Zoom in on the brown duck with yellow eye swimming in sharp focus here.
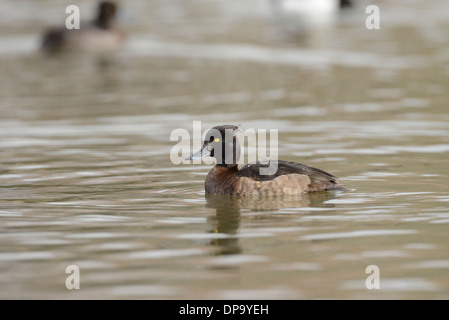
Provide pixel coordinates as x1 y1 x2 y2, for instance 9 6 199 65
186 125 349 197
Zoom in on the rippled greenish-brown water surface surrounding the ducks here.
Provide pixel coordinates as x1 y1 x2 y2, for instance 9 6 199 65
0 0 449 299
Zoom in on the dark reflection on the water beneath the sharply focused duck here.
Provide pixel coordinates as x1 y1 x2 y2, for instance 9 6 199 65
206 192 335 255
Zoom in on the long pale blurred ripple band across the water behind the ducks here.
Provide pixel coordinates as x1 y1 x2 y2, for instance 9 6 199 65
129 38 427 69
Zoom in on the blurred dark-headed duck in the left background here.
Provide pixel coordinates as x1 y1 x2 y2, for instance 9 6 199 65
41 1 126 53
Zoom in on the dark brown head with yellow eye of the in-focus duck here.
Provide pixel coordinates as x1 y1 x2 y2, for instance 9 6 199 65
186 125 241 167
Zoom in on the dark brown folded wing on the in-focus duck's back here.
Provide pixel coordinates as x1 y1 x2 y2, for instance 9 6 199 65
239 160 337 183
